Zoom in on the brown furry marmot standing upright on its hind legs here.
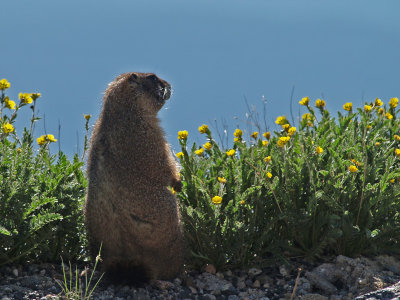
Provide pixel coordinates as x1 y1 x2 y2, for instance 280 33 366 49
84 73 185 281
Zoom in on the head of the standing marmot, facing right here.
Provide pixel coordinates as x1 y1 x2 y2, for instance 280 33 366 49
105 72 171 113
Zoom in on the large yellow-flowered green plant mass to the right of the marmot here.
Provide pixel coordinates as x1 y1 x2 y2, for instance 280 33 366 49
177 97 400 268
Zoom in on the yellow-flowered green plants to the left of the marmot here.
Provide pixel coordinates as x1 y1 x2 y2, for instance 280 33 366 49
0 79 86 265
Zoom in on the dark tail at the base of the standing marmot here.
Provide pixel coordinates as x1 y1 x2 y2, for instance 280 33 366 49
104 263 150 286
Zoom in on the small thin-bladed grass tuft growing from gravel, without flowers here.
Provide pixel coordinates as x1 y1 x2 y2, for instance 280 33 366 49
57 246 104 300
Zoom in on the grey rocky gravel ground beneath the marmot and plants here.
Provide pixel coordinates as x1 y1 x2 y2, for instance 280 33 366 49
0 256 400 300
